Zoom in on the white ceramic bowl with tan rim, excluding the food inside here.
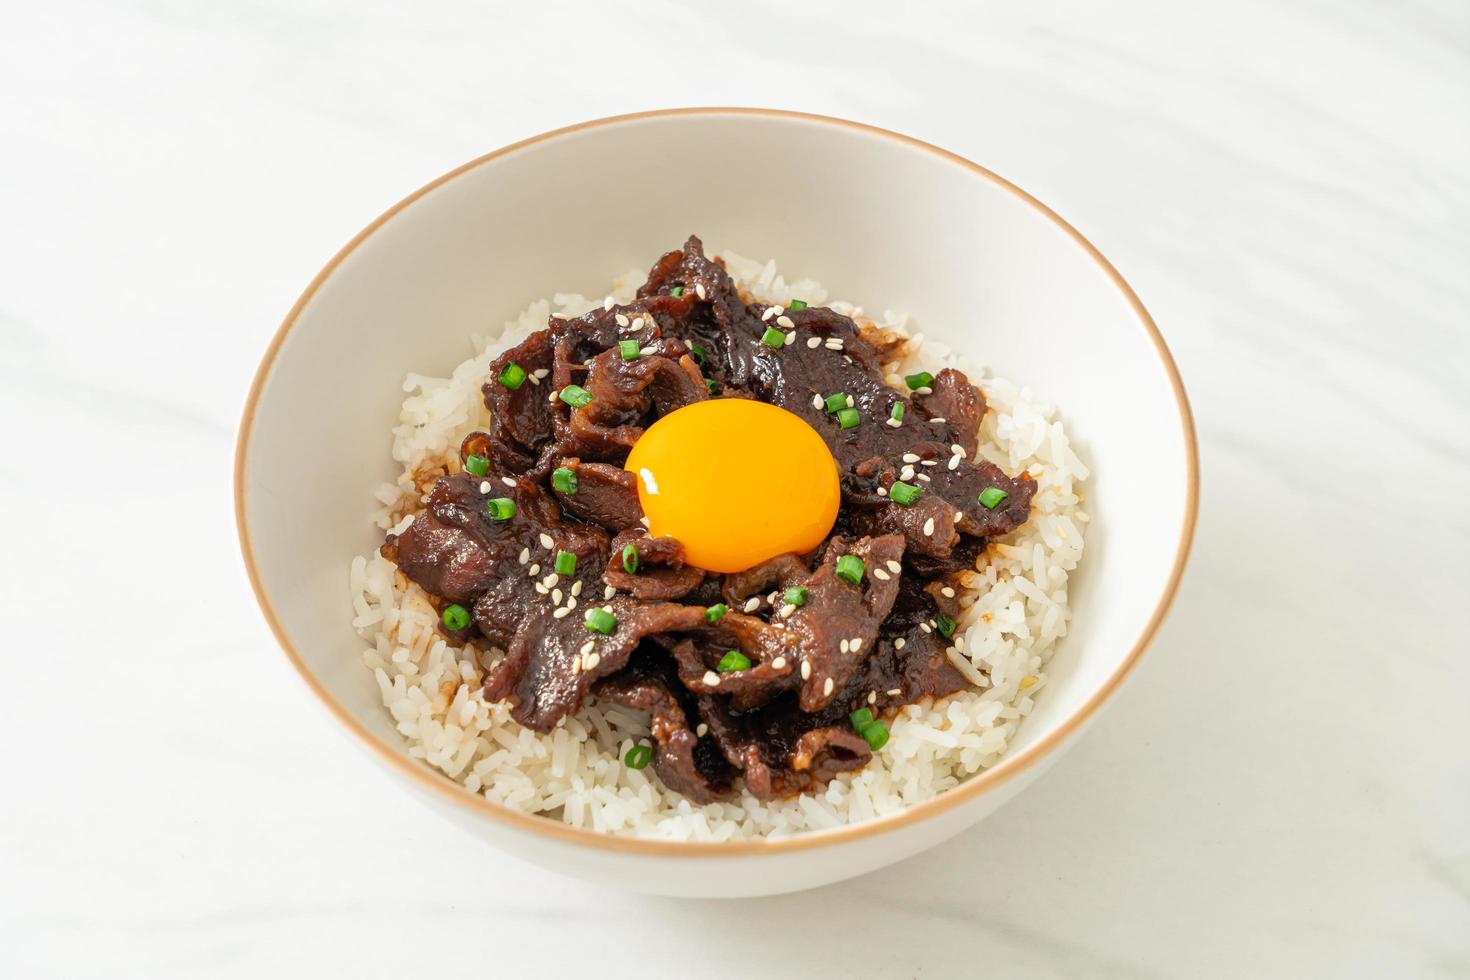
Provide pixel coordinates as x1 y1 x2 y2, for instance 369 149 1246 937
235 109 1198 896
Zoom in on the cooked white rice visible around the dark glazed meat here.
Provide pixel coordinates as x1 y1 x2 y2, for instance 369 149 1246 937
350 253 1088 840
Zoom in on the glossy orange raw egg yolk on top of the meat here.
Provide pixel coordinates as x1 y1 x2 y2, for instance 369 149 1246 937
623 398 839 572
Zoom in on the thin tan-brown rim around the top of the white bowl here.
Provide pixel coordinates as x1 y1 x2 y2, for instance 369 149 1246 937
234 106 1200 858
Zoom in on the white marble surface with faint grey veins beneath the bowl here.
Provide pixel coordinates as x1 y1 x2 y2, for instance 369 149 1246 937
0 0 1470 977
